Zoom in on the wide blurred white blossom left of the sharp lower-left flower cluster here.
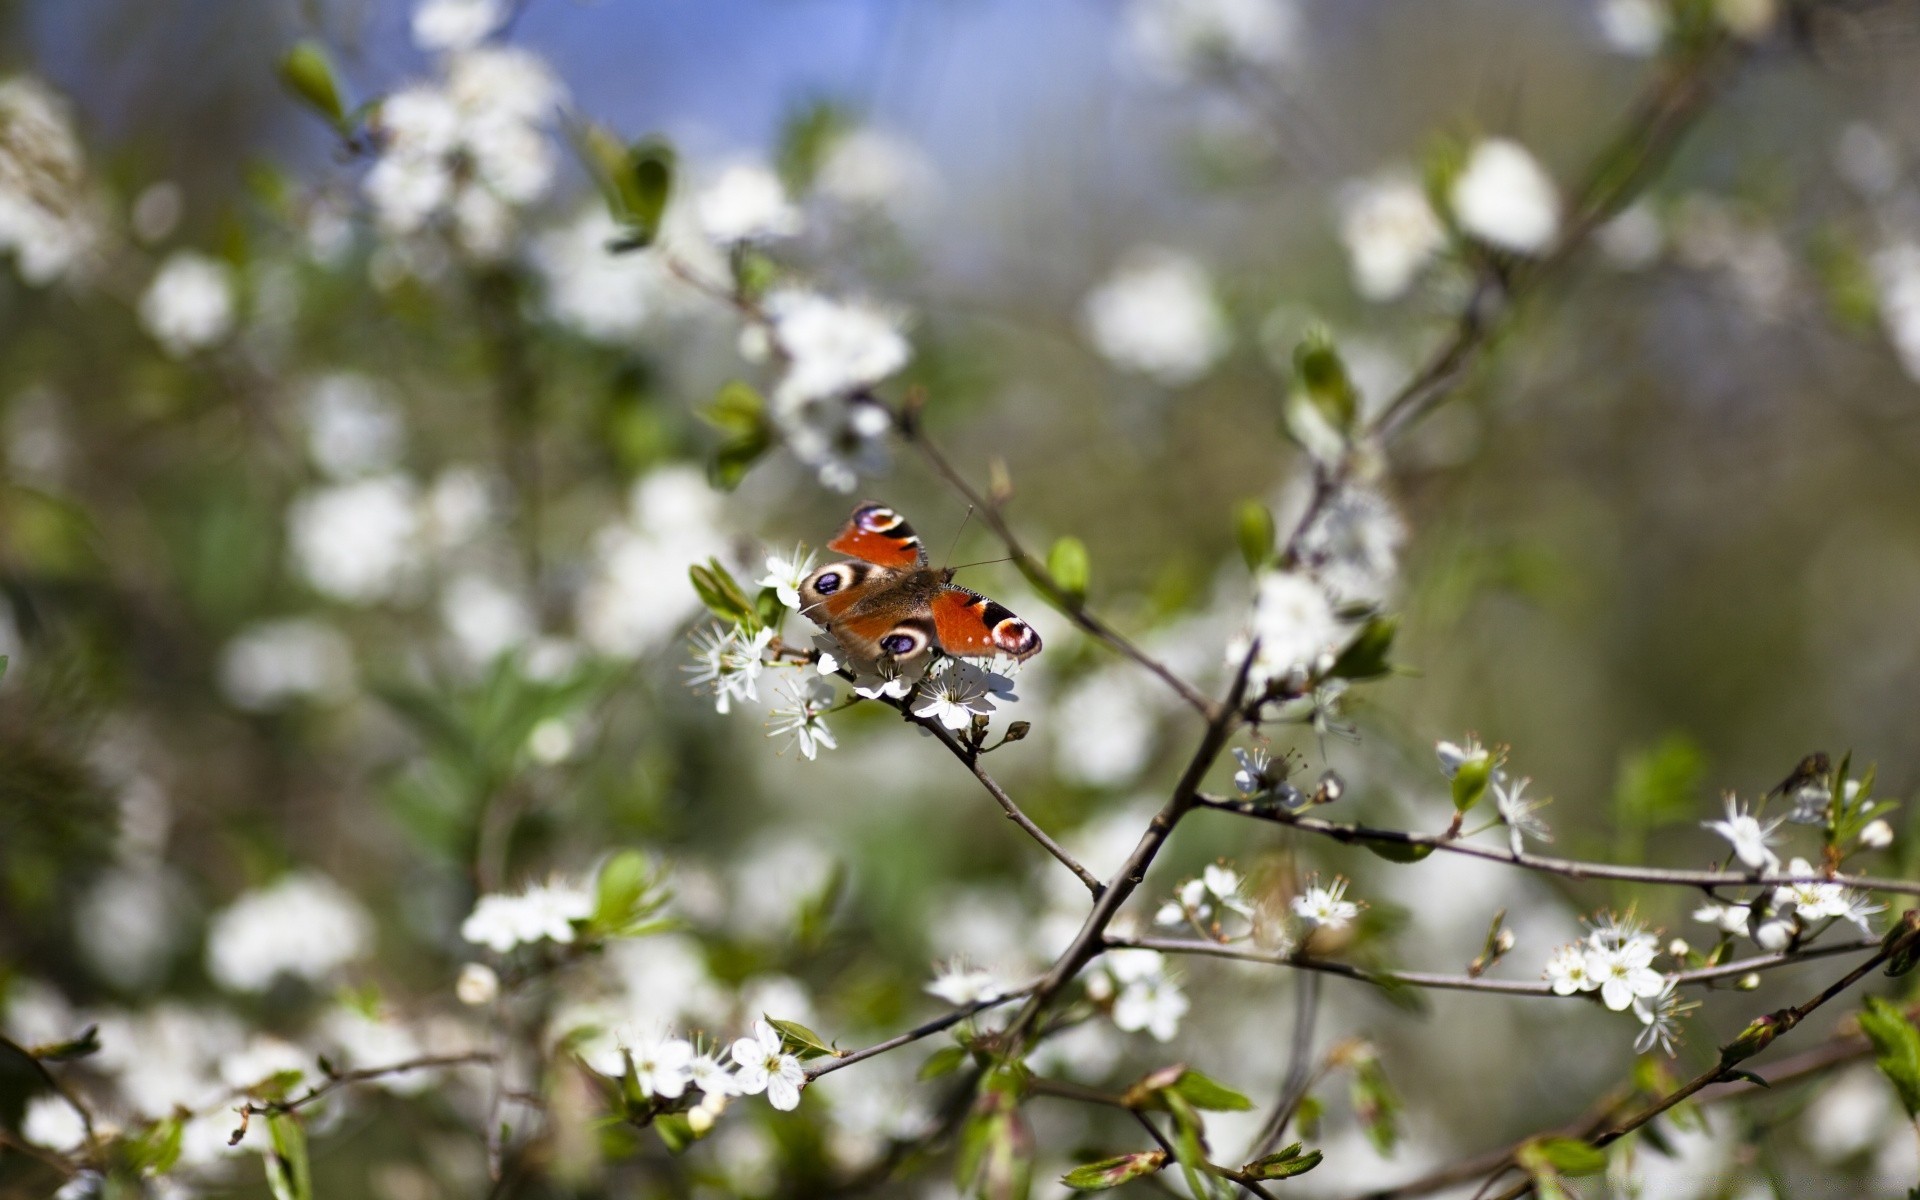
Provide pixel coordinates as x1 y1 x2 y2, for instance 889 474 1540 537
207 874 372 993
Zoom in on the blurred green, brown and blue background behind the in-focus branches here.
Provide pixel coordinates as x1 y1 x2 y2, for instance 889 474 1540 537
0 0 1920 1200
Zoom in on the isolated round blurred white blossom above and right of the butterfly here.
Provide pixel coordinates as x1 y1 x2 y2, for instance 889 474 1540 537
1081 248 1229 388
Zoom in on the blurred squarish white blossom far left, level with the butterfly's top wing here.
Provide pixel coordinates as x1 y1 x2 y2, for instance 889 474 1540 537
286 474 420 605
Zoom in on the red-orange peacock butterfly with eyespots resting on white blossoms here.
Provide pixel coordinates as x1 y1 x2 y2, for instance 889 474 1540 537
801 501 1041 676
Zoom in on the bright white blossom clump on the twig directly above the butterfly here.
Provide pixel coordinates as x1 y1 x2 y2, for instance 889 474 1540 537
762 288 912 415
